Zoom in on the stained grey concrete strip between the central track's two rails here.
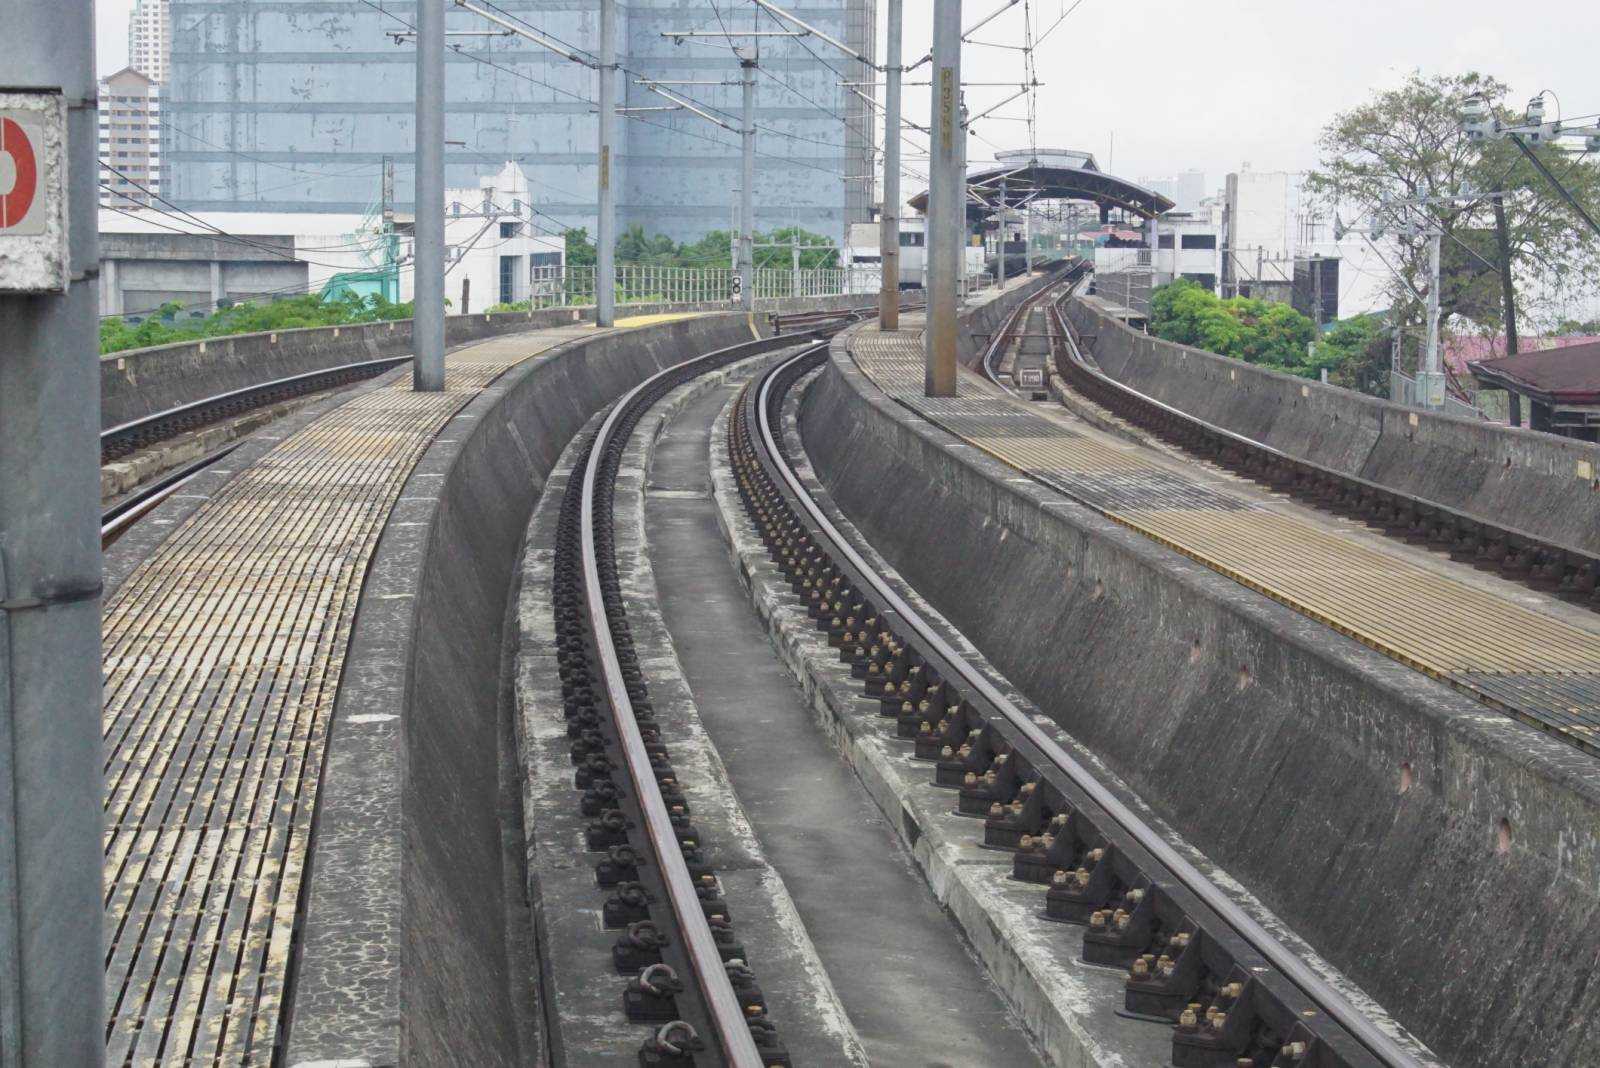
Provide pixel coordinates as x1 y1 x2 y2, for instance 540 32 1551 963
646 378 1038 1066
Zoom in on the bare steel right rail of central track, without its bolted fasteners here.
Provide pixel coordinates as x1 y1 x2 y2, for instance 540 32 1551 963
755 343 1421 1068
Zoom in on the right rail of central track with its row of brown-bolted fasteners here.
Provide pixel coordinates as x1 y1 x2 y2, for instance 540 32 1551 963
728 342 1418 1068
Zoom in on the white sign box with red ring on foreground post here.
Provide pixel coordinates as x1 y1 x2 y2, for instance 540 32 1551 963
0 91 69 293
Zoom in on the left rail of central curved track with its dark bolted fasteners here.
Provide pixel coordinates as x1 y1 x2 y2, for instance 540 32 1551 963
552 329 859 1068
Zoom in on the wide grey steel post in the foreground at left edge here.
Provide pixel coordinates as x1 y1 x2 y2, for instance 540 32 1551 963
0 0 106 1068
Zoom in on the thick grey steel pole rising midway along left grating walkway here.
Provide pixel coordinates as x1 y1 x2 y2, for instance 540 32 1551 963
411 0 445 392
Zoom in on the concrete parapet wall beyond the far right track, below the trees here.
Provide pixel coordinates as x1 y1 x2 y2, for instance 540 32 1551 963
1067 301 1600 553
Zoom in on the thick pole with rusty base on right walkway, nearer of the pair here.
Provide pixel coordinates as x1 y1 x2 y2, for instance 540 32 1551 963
923 0 966 397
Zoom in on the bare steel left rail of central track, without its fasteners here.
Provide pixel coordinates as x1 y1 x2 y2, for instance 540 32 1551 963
581 336 826 1068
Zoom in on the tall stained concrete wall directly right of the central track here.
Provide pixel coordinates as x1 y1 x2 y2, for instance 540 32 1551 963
800 319 1600 1068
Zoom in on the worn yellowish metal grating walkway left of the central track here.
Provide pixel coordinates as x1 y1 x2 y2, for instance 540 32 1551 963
95 323 604 1065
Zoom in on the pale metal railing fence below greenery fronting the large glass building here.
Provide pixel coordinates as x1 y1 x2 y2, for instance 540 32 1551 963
526 264 883 309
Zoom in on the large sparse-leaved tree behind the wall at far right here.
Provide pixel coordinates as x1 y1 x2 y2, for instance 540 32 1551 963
1306 72 1600 351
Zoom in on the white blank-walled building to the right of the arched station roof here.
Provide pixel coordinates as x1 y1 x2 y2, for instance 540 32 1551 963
1222 169 1294 301
